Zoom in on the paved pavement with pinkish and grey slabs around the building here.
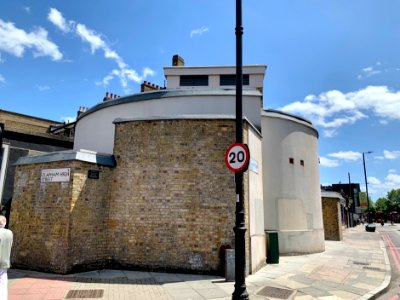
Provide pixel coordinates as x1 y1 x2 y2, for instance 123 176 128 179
8 225 391 300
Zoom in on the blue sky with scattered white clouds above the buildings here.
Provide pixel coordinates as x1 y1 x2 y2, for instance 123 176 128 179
0 0 400 200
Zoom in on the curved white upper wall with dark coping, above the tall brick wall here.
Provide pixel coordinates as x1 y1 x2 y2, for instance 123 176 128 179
74 90 261 154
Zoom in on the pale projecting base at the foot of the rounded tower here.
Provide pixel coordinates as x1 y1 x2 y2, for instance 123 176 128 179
278 228 325 255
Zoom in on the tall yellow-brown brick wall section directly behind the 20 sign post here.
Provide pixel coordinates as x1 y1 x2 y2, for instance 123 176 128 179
108 120 248 271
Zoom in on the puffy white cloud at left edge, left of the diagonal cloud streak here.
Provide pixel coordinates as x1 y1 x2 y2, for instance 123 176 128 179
0 19 62 60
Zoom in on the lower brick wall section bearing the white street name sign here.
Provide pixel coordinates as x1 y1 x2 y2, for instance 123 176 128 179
10 161 111 273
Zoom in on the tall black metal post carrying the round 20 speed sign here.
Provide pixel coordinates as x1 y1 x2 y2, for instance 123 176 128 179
232 0 249 300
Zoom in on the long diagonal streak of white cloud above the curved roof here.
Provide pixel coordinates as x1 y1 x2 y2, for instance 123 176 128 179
48 8 155 91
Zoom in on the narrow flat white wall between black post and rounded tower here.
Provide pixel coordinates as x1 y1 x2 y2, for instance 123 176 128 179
247 127 266 274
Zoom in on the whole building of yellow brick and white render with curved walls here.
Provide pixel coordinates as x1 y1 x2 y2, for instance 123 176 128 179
11 55 324 273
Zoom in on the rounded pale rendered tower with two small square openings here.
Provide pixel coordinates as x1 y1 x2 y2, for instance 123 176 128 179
261 111 325 254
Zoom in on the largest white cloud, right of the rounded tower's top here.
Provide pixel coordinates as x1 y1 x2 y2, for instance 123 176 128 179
279 86 400 137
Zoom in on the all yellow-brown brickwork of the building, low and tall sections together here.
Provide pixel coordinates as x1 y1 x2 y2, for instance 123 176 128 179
11 119 250 273
